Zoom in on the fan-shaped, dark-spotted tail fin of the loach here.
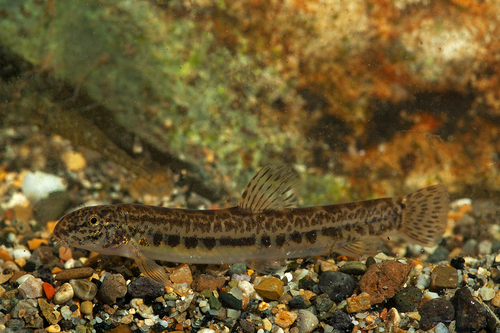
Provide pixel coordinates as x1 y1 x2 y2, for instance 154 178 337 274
399 185 449 246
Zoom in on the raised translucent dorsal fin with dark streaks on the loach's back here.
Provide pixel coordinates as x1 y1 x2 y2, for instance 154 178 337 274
238 164 298 212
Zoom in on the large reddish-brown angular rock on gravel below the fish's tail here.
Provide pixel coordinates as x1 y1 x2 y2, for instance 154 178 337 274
359 261 413 304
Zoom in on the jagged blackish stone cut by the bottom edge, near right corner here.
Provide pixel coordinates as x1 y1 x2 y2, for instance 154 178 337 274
452 287 487 332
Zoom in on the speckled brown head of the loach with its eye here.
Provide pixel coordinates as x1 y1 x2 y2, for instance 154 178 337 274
52 206 129 254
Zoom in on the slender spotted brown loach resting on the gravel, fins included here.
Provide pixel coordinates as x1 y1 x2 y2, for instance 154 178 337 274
53 165 449 286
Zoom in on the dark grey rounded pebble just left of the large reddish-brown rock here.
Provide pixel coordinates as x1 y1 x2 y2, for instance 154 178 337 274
318 271 356 302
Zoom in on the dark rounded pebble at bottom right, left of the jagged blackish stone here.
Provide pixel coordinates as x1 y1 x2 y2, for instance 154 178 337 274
418 298 455 331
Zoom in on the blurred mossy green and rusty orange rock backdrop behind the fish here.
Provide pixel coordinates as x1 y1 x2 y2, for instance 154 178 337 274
0 0 500 206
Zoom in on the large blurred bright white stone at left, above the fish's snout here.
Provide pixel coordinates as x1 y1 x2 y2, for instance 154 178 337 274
21 171 68 202
